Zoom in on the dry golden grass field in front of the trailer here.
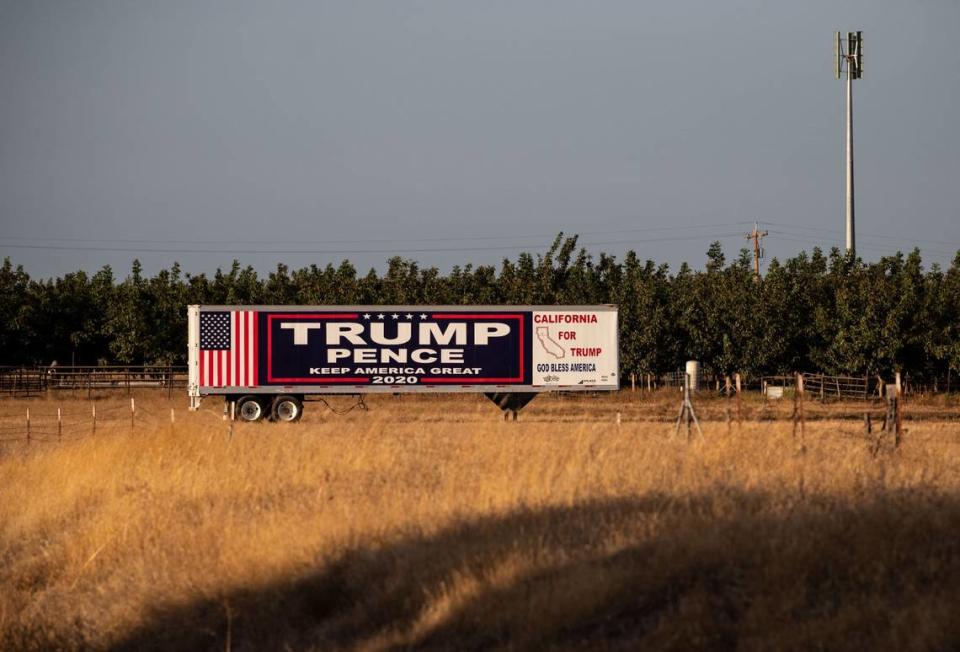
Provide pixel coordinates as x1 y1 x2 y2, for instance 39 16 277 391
0 392 960 650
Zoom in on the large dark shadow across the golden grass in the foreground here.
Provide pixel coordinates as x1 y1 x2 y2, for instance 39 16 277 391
116 491 960 650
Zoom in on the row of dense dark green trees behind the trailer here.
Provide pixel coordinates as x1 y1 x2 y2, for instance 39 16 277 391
0 233 960 380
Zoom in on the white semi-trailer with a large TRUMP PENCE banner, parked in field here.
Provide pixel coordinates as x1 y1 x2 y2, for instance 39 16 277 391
187 304 620 422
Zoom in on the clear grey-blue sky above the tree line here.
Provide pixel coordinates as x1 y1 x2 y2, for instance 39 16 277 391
0 0 960 277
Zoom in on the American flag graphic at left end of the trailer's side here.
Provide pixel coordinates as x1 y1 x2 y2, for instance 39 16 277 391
200 310 257 387
